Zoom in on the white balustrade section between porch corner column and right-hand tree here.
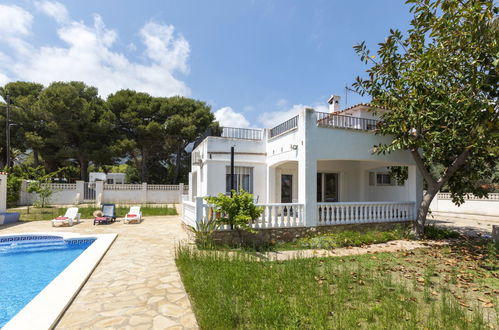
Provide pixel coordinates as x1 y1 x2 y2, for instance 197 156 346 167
317 202 415 226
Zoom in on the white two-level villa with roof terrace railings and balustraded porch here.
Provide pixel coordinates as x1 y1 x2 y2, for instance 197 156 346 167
183 96 423 228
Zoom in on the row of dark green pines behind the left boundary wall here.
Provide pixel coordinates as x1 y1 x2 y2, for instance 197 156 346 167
0 81 218 183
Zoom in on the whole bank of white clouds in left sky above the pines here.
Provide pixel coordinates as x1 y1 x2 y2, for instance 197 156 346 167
0 3 190 96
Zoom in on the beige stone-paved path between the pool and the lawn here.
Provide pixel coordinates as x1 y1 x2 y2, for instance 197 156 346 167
0 216 198 329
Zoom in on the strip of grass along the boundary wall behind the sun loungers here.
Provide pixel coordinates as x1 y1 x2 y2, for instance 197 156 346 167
9 204 177 221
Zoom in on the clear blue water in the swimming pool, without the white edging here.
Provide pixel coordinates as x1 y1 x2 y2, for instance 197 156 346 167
0 236 95 328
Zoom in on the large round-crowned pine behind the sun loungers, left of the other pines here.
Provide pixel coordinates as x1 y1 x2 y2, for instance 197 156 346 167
35 81 115 181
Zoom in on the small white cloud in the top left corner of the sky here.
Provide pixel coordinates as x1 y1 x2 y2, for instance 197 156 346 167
0 5 33 40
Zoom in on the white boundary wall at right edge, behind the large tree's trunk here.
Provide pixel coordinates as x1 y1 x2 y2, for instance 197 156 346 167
430 193 499 217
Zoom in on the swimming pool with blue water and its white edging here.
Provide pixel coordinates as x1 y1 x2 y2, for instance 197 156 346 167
0 233 116 329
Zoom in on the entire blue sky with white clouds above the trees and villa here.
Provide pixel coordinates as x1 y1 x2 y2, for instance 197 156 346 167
0 0 410 127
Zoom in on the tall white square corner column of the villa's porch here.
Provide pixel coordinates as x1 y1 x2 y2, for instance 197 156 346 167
298 109 317 227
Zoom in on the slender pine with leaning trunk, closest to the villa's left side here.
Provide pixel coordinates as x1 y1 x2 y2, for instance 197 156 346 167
164 96 218 183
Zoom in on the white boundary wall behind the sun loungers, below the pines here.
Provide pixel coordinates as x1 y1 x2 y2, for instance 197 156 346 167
18 181 189 205
